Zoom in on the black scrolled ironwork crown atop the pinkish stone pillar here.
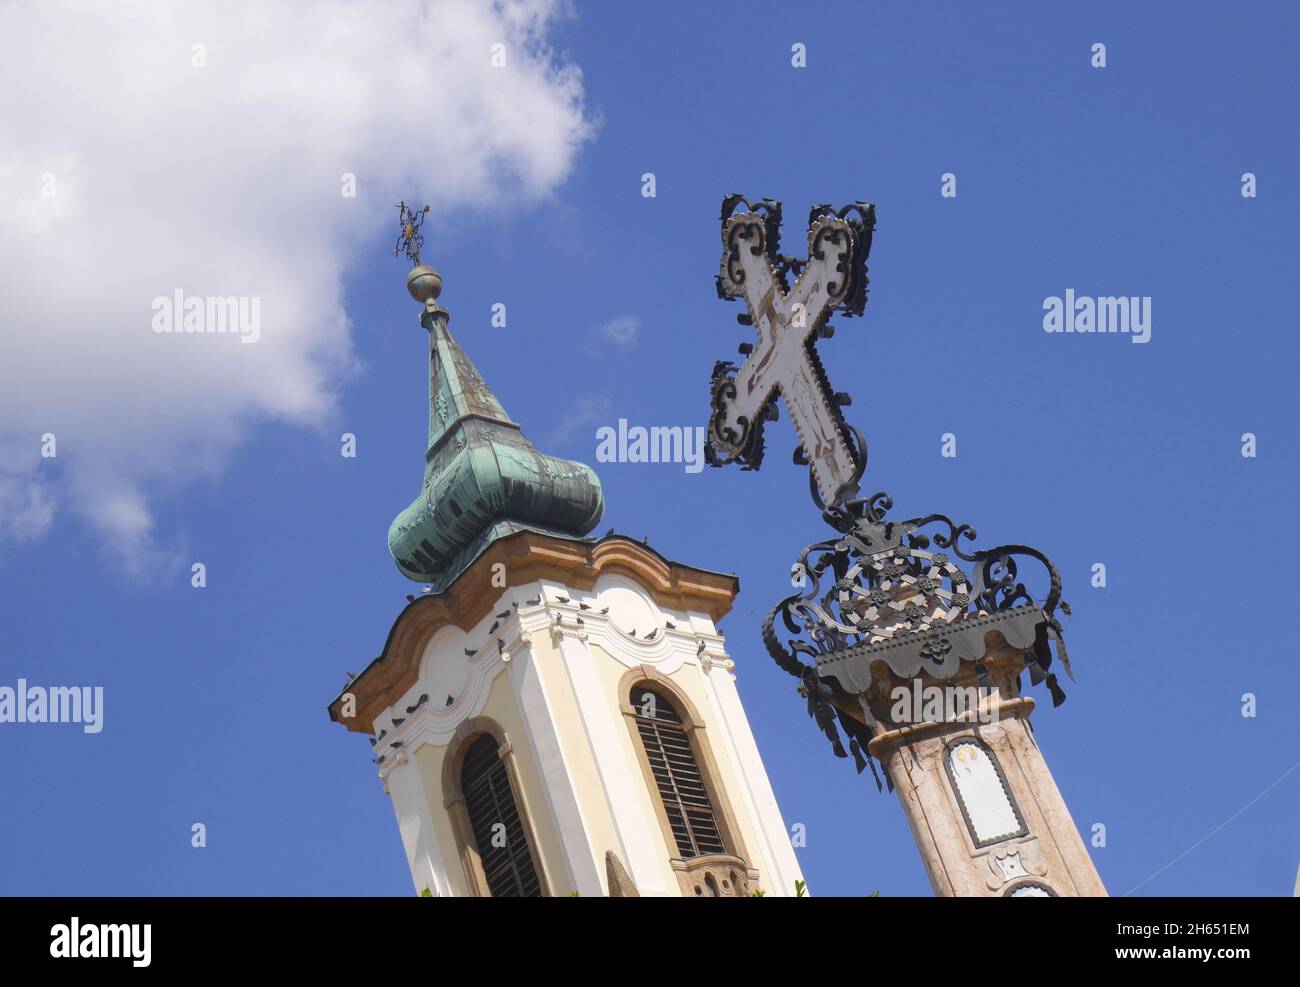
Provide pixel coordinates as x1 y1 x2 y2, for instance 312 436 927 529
763 493 1074 784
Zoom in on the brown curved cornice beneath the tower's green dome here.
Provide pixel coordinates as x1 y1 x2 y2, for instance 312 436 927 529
329 531 740 733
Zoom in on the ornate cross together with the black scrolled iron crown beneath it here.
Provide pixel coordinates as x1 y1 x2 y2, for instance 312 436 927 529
706 195 1074 785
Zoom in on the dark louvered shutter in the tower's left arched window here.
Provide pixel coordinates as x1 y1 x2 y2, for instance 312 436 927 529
460 733 542 897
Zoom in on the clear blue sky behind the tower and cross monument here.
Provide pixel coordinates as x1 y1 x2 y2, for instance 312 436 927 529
0 3 1300 896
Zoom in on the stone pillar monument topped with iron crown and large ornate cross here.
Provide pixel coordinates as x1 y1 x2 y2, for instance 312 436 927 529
706 195 1106 897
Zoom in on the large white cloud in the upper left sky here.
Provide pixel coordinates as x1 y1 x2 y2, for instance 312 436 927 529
0 0 592 568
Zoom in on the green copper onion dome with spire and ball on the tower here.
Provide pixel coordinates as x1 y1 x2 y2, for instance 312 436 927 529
389 264 605 593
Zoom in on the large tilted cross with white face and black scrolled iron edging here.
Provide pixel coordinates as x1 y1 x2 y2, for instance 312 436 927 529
707 195 875 506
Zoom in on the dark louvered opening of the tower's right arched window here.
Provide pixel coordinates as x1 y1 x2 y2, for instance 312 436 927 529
629 685 728 860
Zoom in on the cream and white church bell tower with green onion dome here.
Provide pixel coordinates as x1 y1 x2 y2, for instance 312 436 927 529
329 252 802 897
